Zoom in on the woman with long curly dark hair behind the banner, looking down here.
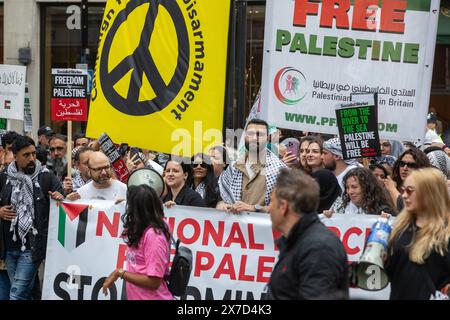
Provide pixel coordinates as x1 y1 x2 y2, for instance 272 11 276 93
324 168 396 217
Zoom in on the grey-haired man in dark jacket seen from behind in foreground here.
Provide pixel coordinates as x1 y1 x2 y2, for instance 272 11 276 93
268 169 349 300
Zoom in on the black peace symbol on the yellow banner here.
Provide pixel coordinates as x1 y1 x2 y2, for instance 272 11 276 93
100 0 189 116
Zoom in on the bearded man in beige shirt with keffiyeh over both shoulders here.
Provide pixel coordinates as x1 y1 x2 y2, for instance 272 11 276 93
219 119 286 213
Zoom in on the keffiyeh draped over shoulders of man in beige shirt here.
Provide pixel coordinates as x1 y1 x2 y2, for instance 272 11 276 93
219 150 287 205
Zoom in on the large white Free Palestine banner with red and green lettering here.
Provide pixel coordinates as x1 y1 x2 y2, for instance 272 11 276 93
261 0 439 141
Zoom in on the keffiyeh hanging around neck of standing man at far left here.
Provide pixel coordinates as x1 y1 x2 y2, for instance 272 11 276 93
7 160 48 251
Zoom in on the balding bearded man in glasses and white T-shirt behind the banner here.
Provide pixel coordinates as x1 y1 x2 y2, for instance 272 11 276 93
67 151 127 201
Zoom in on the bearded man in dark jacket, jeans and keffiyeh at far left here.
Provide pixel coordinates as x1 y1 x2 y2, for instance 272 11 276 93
0 135 63 300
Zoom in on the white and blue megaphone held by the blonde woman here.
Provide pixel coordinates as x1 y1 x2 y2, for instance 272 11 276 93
355 218 392 291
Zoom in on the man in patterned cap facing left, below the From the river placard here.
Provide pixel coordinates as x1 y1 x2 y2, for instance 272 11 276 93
322 138 358 190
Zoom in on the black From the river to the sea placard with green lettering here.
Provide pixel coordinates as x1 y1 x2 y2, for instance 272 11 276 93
336 94 380 160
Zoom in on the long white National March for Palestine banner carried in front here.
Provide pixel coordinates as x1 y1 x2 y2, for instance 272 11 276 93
43 200 389 300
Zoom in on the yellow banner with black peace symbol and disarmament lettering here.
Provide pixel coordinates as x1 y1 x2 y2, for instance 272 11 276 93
86 0 230 156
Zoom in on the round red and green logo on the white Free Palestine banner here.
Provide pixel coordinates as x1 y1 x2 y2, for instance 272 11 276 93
274 67 306 105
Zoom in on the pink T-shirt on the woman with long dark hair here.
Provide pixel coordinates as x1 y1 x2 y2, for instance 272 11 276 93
126 227 173 300
